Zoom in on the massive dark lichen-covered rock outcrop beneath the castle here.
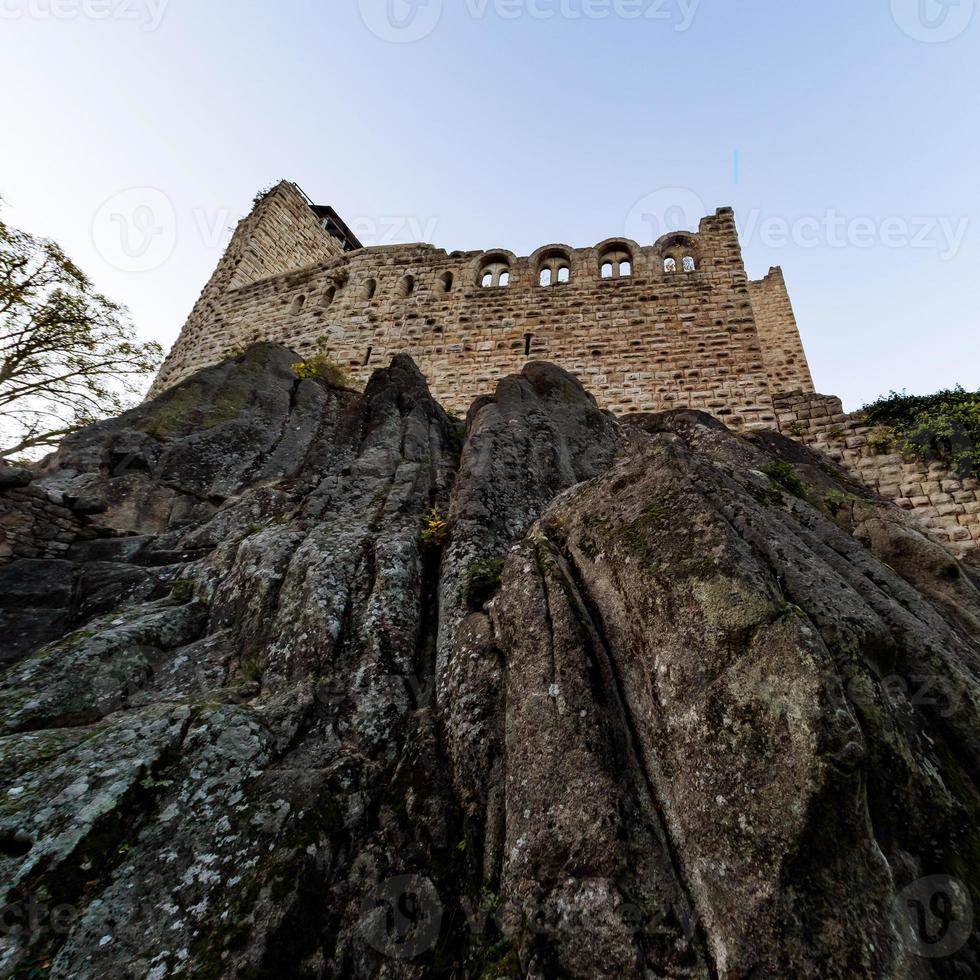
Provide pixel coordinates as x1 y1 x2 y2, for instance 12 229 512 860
0 345 980 978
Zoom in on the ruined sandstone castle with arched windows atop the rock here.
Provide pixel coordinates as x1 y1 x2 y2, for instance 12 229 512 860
152 182 813 427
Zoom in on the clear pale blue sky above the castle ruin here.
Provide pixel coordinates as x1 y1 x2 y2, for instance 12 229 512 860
0 0 980 408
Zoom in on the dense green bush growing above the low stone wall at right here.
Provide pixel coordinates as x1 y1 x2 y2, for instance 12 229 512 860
863 387 980 478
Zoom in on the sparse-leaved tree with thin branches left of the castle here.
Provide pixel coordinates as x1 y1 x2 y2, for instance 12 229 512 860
0 202 163 459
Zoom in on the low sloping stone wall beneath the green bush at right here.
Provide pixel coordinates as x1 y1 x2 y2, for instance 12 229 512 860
773 391 980 557
